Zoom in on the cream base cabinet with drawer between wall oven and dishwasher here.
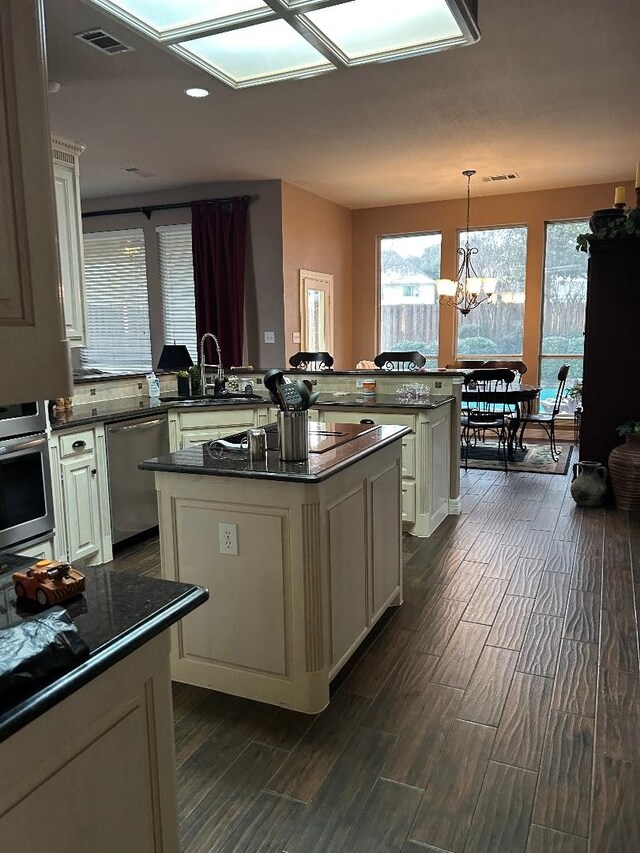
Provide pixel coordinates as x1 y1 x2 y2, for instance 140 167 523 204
49 424 112 565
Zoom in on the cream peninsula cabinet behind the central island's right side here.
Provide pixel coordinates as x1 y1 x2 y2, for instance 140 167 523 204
319 403 451 536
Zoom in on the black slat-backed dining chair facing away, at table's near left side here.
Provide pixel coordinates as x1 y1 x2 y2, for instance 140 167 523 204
460 368 515 471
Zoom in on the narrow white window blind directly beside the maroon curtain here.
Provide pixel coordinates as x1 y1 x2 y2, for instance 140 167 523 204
156 224 198 364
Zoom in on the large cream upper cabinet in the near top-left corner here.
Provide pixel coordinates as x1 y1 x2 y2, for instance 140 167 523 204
0 0 73 404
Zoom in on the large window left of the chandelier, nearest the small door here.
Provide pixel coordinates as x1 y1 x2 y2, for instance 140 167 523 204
380 234 442 367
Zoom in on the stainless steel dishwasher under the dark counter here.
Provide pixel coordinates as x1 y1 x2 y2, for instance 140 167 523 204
105 414 169 545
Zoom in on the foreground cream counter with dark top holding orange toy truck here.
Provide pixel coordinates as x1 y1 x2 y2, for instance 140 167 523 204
0 554 207 853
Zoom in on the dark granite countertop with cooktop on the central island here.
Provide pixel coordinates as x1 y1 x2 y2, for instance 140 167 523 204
138 421 411 483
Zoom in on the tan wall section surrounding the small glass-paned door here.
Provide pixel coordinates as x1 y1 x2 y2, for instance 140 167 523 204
282 181 353 370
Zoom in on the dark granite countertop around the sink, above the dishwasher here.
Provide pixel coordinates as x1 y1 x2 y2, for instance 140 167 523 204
50 397 267 430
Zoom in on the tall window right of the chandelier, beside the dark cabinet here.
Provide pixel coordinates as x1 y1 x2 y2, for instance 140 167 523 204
540 220 588 413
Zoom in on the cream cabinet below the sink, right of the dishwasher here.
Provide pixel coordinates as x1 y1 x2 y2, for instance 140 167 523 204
169 406 267 453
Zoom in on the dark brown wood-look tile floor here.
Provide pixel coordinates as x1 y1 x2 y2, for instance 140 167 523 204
107 456 640 853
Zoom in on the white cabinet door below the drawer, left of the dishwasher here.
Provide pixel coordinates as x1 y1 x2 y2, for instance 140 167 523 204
60 455 101 562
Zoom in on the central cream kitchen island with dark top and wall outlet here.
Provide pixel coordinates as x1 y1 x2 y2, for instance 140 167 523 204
141 419 409 713
